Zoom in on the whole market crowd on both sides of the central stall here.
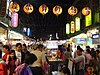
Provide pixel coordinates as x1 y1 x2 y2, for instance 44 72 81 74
0 43 100 75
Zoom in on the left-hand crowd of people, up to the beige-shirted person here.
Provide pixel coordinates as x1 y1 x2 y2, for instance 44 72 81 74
0 43 46 75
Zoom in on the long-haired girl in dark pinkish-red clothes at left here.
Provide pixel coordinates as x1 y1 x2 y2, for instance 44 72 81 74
6 50 20 75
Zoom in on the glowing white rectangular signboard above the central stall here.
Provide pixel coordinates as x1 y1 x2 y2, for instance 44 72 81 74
46 40 59 49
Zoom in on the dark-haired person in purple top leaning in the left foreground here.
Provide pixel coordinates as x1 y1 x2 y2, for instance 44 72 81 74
14 54 37 75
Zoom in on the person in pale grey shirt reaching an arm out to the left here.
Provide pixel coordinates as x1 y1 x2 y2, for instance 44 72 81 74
70 48 85 75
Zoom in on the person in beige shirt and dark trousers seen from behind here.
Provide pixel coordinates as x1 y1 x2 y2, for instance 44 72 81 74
30 44 46 75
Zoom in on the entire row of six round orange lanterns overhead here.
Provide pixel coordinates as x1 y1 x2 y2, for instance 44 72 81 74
9 2 91 16
